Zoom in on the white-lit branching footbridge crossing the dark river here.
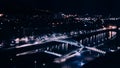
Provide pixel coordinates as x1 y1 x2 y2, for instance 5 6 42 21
16 36 106 63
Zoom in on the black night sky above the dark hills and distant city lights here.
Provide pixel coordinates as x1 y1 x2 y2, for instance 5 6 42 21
0 0 120 15
